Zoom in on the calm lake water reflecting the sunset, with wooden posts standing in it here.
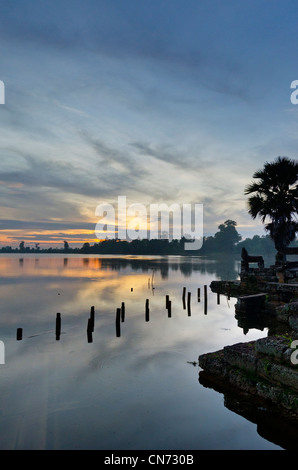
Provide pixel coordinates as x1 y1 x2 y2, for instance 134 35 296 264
0 254 294 450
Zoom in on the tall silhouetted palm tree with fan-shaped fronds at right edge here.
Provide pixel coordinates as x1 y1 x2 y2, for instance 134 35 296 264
245 157 298 253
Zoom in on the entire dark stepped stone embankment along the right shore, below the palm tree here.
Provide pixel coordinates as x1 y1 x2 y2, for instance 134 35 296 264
199 282 298 419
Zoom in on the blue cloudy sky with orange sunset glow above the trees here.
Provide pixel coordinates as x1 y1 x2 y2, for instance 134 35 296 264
0 0 298 247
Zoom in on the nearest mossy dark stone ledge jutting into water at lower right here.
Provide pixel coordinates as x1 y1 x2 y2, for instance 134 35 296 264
199 337 298 417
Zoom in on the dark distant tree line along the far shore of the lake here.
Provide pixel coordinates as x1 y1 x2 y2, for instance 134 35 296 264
0 219 298 255
